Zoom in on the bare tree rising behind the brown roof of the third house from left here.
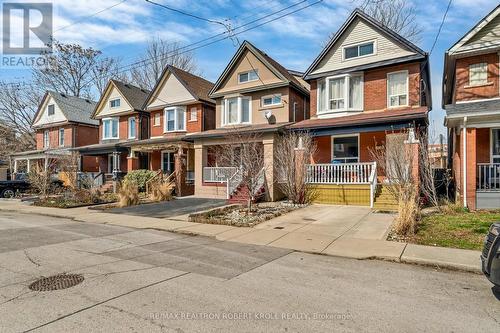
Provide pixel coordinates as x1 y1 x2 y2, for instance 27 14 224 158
130 38 197 90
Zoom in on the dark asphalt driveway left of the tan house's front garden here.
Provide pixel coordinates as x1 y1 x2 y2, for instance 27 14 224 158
106 197 226 220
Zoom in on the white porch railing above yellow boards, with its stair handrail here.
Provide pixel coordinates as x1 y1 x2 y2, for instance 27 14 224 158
306 162 377 207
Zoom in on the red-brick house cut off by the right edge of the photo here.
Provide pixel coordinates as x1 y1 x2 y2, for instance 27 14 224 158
442 6 500 209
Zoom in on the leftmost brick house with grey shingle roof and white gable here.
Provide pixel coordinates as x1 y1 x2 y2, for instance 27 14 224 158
12 91 99 174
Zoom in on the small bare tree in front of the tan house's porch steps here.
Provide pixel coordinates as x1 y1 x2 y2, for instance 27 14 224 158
216 129 267 213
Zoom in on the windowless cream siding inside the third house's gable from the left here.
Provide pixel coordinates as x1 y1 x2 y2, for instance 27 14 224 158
147 73 195 109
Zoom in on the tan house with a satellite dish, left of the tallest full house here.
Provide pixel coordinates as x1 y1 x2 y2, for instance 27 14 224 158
188 41 309 200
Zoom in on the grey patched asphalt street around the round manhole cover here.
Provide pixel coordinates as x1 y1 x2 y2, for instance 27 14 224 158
0 212 500 332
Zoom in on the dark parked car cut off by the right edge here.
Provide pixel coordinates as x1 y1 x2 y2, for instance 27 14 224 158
481 223 500 288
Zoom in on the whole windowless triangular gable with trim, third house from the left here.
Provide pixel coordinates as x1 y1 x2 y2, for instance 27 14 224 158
144 66 198 110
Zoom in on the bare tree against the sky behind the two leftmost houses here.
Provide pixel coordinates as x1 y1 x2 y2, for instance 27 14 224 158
32 40 122 98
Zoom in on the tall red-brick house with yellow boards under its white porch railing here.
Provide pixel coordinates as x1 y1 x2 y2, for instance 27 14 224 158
291 9 431 208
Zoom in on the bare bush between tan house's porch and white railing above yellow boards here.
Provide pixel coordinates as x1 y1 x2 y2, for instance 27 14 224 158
274 132 316 204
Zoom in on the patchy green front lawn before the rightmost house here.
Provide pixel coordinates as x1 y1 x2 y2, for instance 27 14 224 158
408 211 500 250
